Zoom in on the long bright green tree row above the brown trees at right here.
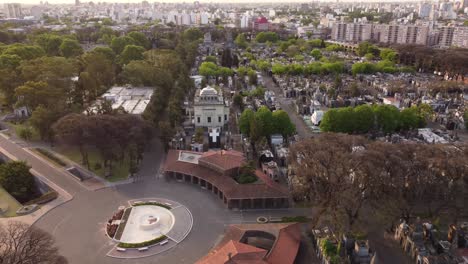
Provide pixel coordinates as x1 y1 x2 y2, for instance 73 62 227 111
320 104 432 134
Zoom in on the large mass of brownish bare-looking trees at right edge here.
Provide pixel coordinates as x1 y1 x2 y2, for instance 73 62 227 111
290 133 468 235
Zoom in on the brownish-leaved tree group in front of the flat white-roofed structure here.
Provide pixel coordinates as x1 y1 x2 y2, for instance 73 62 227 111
53 113 151 173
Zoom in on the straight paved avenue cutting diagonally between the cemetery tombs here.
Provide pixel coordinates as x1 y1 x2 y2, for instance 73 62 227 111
262 75 314 138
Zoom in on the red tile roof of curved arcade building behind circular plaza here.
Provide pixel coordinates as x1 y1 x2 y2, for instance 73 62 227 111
163 150 289 199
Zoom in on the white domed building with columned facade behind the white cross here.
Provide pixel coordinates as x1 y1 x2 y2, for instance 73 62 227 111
193 86 229 128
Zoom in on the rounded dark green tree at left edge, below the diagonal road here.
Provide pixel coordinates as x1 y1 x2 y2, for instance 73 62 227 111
0 161 38 203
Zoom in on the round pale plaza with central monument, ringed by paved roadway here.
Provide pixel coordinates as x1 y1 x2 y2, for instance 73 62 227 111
106 198 193 258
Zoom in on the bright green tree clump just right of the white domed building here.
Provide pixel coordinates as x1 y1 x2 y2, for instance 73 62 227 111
239 106 296 149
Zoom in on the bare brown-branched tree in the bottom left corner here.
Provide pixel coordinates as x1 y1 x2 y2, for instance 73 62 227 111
0 221 68 264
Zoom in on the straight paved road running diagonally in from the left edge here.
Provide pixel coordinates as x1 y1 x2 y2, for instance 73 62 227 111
0 134 86 196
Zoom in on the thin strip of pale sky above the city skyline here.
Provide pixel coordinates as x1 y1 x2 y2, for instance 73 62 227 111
0 0 422 7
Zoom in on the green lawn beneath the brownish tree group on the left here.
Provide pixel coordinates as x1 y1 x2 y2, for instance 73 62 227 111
54 146 130 182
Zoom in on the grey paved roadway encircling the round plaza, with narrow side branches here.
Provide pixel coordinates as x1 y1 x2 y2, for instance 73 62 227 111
31 138 308 264
